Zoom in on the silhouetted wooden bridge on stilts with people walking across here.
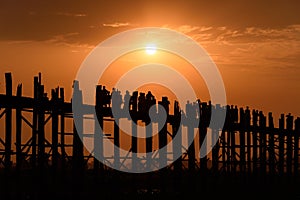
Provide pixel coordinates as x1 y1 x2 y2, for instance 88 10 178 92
0 73 300 199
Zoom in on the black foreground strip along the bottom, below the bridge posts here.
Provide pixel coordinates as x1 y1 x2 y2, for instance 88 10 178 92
0 170 300 200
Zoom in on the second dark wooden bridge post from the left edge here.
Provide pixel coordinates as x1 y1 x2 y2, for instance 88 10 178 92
16 84 22 171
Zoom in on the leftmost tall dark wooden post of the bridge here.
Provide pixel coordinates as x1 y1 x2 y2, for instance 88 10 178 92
4 73 12 169
